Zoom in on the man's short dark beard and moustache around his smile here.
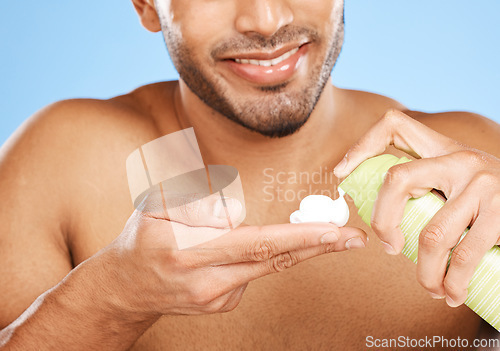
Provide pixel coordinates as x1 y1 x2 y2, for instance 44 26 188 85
162 18 344 138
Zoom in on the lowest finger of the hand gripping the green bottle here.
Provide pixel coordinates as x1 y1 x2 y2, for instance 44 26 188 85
444 214 500 307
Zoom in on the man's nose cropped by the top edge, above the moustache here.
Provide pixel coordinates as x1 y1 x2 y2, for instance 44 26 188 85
235 0 293 37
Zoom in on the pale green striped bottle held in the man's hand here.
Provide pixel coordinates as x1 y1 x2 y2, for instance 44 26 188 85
339 154 500 331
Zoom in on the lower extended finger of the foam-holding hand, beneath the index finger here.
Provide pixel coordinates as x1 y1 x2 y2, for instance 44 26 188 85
211 227 368 293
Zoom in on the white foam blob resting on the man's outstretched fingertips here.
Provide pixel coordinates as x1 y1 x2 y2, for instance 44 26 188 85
290 189 349 227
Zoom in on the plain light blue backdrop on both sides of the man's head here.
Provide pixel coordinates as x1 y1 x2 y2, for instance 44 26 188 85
0 0 500 145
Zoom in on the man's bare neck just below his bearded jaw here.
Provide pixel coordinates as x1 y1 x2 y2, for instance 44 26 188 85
174 80 340 173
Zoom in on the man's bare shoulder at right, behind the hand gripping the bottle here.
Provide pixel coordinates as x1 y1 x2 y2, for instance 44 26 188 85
403 110 500 157
